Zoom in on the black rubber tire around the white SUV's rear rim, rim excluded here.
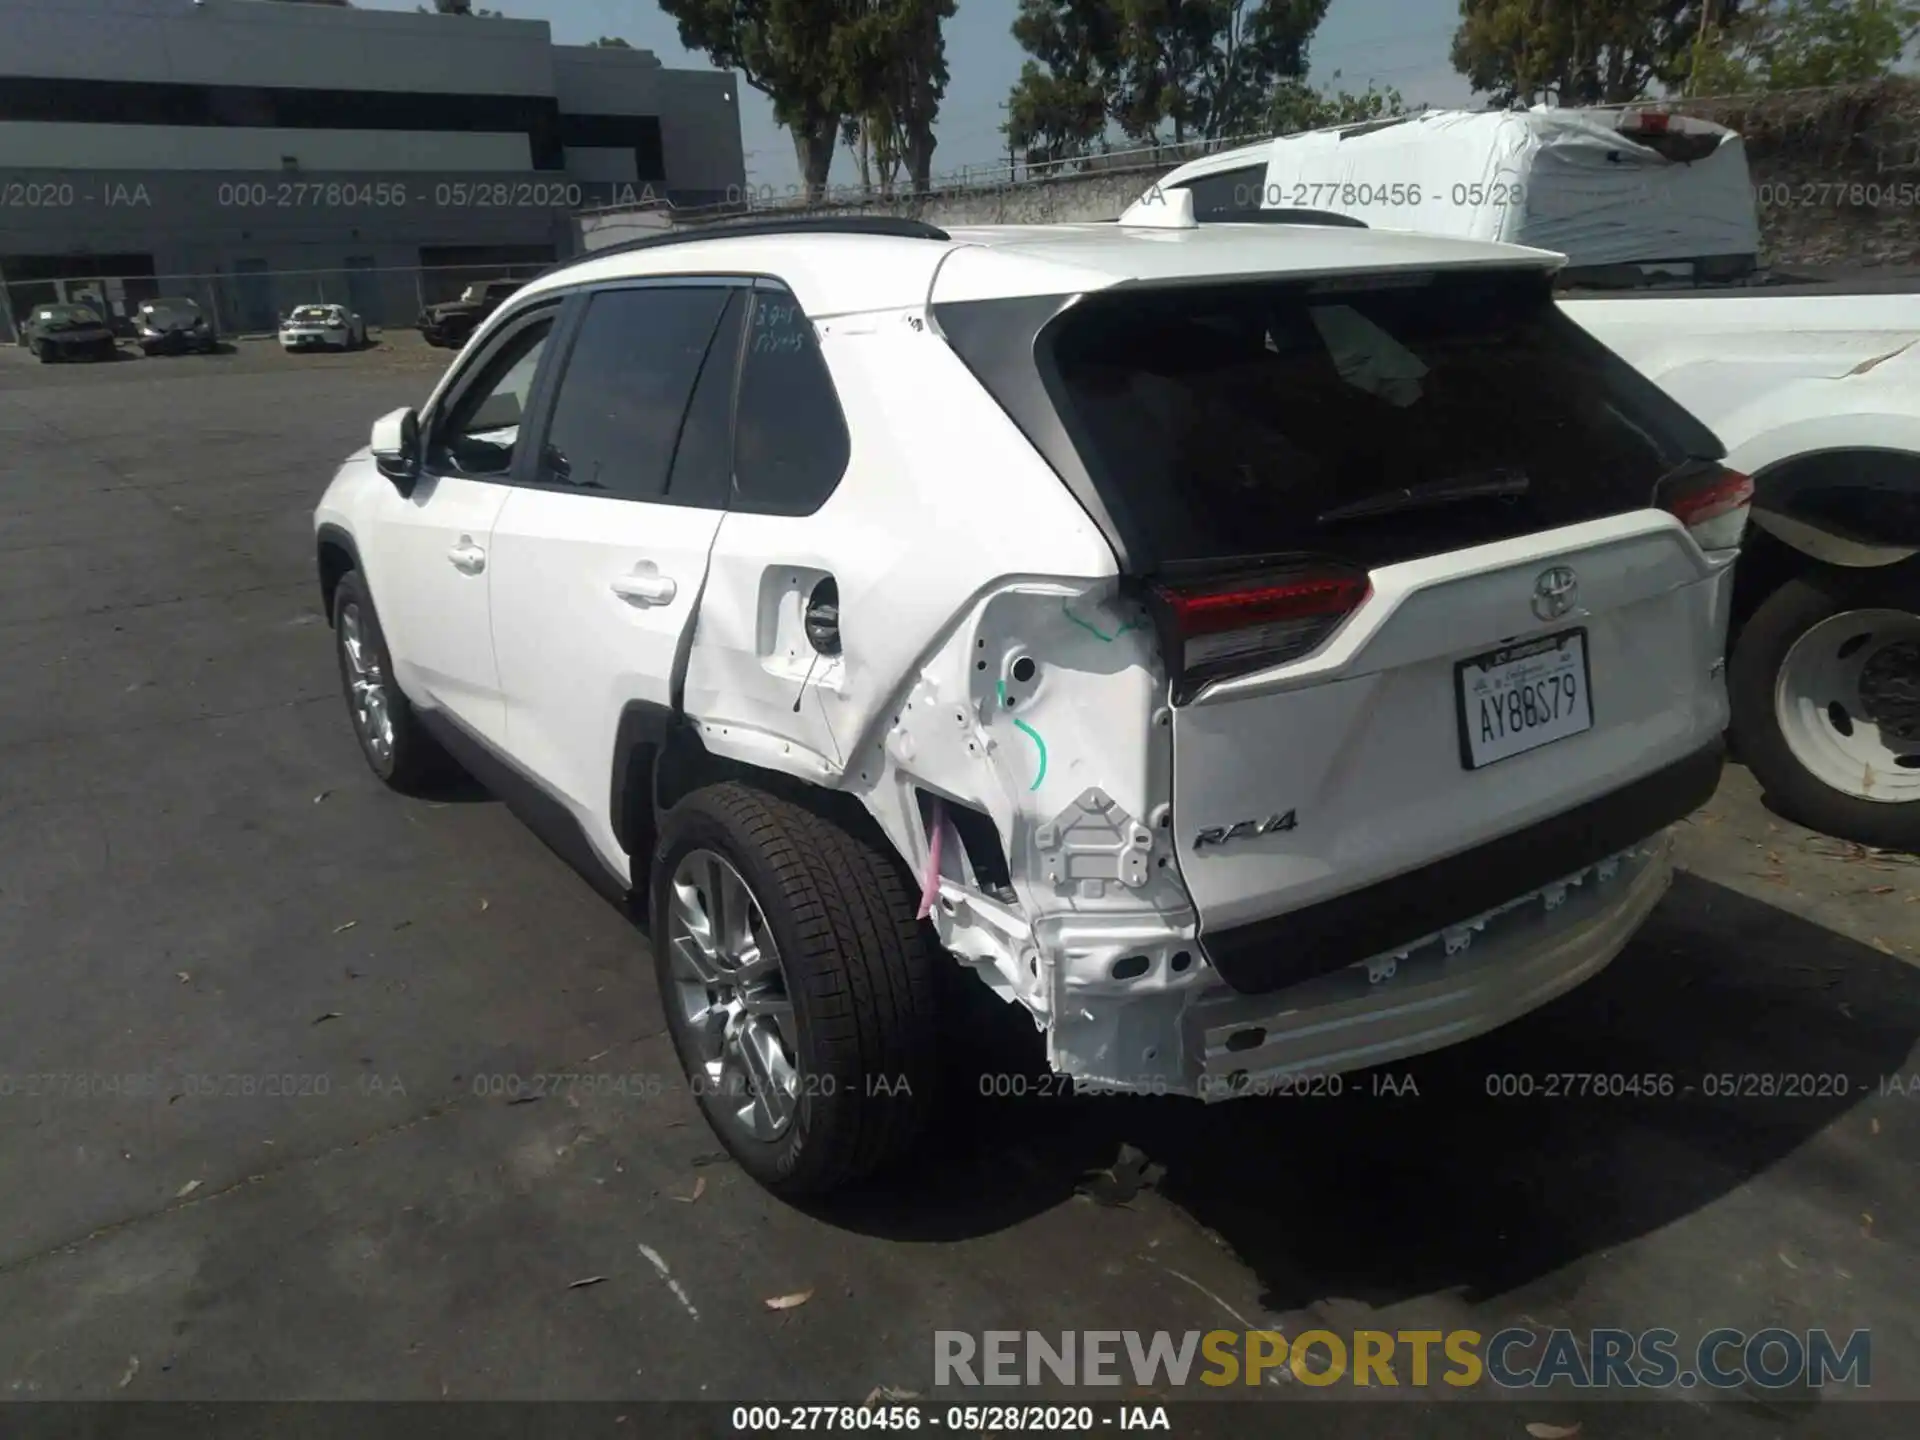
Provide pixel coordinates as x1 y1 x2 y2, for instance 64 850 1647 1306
649 781 939 1198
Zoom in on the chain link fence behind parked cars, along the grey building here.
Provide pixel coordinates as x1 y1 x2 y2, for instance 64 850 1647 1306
0 261 551 344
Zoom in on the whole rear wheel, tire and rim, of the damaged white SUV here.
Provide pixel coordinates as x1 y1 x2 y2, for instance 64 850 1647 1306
651 781 937 1196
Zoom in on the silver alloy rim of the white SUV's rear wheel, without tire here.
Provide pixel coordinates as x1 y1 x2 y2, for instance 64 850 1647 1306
666 851 801 1142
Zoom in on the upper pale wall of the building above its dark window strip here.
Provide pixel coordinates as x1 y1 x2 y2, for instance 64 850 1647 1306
0 0 553 96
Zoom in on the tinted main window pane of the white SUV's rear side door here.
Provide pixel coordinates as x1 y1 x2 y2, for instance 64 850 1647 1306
538 286 732 501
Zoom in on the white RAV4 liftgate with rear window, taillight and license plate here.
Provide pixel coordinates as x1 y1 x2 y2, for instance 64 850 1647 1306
1050 275 1730 989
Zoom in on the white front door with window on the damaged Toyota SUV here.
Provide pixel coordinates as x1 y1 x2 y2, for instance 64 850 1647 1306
367 309 555 745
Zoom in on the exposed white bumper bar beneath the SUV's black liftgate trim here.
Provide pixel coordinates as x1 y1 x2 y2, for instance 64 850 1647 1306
1183 831 1672 1100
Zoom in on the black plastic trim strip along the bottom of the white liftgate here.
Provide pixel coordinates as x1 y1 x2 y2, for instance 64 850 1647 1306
1200 739 1726 995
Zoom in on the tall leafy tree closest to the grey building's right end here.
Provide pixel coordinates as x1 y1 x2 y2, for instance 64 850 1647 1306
660 0 851 196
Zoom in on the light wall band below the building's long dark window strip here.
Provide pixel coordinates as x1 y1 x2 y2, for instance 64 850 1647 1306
0 121 529 179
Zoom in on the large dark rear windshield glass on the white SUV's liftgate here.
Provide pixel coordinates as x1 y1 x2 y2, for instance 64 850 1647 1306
1043 275 1720 568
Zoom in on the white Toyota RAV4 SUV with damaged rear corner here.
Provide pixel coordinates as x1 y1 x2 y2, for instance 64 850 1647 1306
315 204 1747 1192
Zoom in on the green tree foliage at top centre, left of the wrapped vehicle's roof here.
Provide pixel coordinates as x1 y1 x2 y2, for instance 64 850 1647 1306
1006 0 1327 159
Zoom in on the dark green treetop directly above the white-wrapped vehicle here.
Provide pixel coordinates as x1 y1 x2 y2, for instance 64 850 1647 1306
1452 0 1743 106
